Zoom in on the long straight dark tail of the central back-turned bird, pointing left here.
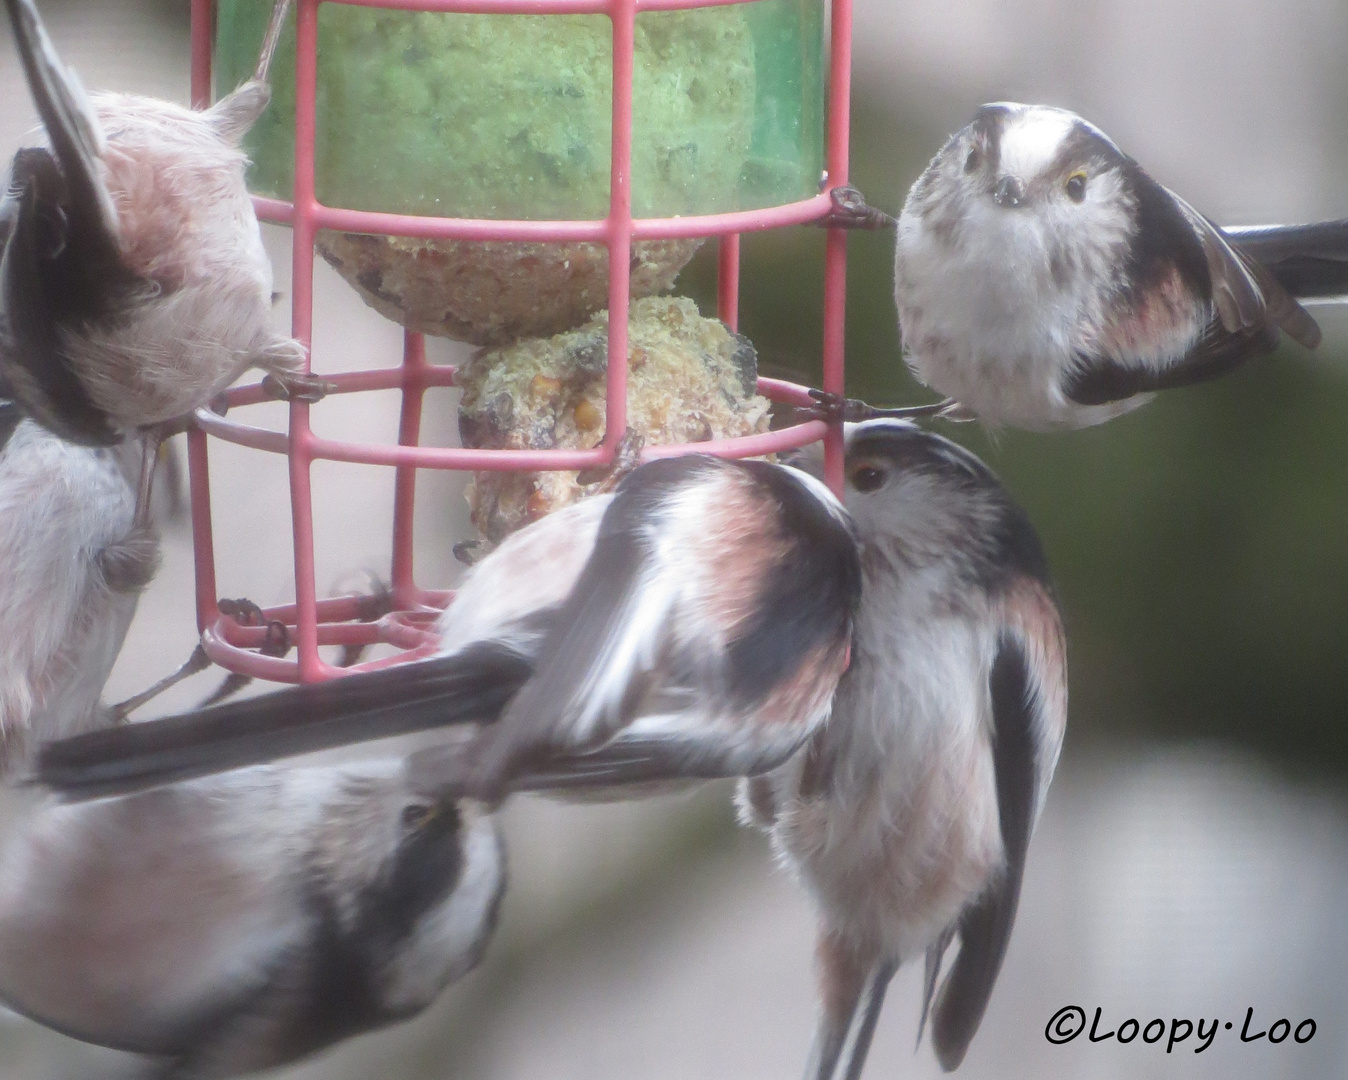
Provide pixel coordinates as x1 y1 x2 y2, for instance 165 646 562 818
32 642 532 801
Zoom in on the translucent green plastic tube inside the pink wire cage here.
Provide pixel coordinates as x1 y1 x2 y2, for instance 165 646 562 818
214 0 825 220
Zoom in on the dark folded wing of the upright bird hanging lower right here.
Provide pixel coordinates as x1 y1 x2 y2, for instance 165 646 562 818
931 634 1038 1072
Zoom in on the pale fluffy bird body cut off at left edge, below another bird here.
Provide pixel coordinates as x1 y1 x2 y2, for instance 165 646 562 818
0 402 159 773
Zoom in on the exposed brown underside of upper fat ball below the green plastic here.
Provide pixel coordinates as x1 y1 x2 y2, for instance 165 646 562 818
318 232 702 345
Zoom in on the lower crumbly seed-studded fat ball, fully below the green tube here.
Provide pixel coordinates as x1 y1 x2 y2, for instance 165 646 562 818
457 297 770 545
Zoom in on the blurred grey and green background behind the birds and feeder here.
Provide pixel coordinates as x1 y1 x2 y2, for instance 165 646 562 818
0 0 1348 1080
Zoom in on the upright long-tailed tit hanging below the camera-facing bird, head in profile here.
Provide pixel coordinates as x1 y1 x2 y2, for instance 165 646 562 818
740 421 1068 1080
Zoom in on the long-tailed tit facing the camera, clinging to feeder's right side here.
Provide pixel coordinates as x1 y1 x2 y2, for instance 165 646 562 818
822 102 1326 430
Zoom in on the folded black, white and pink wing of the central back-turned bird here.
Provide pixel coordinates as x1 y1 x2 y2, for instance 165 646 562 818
410 456 860 797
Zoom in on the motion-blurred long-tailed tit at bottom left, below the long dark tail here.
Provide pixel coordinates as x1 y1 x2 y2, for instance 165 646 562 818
0 759 506 1080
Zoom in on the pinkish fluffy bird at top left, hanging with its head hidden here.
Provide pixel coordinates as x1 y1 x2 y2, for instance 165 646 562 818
0 0 322 525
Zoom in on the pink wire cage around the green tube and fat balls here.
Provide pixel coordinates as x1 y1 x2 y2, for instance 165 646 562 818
187 0 852 682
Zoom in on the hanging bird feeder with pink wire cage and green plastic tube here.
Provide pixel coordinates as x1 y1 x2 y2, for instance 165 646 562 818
189 0 851 682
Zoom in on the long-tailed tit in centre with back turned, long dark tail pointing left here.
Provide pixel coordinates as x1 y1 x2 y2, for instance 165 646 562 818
36 456 860 798
